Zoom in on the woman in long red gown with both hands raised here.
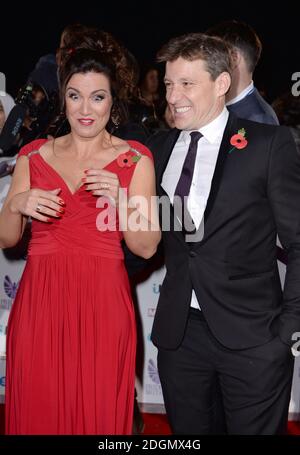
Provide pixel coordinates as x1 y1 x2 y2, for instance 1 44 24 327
0 39 160 434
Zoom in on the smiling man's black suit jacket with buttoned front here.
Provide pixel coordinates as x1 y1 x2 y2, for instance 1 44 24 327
148 114 300 349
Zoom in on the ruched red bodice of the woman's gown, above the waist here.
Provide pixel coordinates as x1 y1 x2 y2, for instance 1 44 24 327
24 141 149 259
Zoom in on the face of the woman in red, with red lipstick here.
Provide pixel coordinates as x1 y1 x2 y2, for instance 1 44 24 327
65 72 113 138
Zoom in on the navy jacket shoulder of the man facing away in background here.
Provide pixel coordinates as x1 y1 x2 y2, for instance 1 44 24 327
227 88 279 125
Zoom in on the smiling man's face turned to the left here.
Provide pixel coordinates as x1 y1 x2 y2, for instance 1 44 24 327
165 57 227 131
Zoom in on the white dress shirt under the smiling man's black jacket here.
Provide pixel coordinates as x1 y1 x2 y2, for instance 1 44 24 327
161 107 229 309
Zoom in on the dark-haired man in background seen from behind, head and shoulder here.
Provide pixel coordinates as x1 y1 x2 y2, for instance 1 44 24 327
206 20 278 125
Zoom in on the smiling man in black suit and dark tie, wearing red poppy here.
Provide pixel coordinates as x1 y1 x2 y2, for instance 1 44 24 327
148 34 300 434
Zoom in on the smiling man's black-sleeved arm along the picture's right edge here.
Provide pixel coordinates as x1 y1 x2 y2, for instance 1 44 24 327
268 127 300 345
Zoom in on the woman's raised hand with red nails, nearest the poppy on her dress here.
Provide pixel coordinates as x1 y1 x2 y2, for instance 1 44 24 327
82 169 120 205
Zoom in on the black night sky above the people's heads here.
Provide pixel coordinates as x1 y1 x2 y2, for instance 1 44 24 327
0 0 300 101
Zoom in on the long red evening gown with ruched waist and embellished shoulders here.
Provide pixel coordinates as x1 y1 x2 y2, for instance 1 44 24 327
6 139 151 434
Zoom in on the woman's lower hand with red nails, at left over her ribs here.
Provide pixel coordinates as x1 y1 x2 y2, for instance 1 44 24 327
9 188 65 222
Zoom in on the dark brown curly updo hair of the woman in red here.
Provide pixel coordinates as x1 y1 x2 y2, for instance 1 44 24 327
59 26 137 124
